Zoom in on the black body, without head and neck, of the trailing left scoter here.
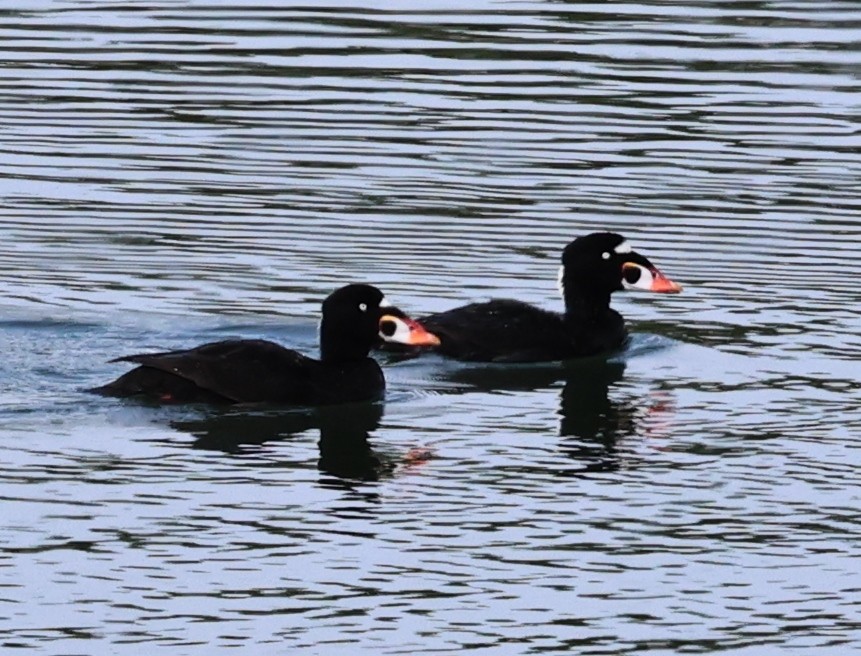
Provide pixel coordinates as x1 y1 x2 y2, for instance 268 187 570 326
93 339 386 405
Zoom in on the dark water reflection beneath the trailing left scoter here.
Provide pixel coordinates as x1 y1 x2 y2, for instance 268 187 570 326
171 403 397 481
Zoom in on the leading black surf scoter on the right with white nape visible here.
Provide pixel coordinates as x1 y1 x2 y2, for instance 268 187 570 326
394 232 682 362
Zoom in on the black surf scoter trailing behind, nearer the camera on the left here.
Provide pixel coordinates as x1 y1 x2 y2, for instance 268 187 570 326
91 284 439 405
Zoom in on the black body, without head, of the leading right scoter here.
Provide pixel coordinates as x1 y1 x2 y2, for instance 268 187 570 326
419 299 627 362
